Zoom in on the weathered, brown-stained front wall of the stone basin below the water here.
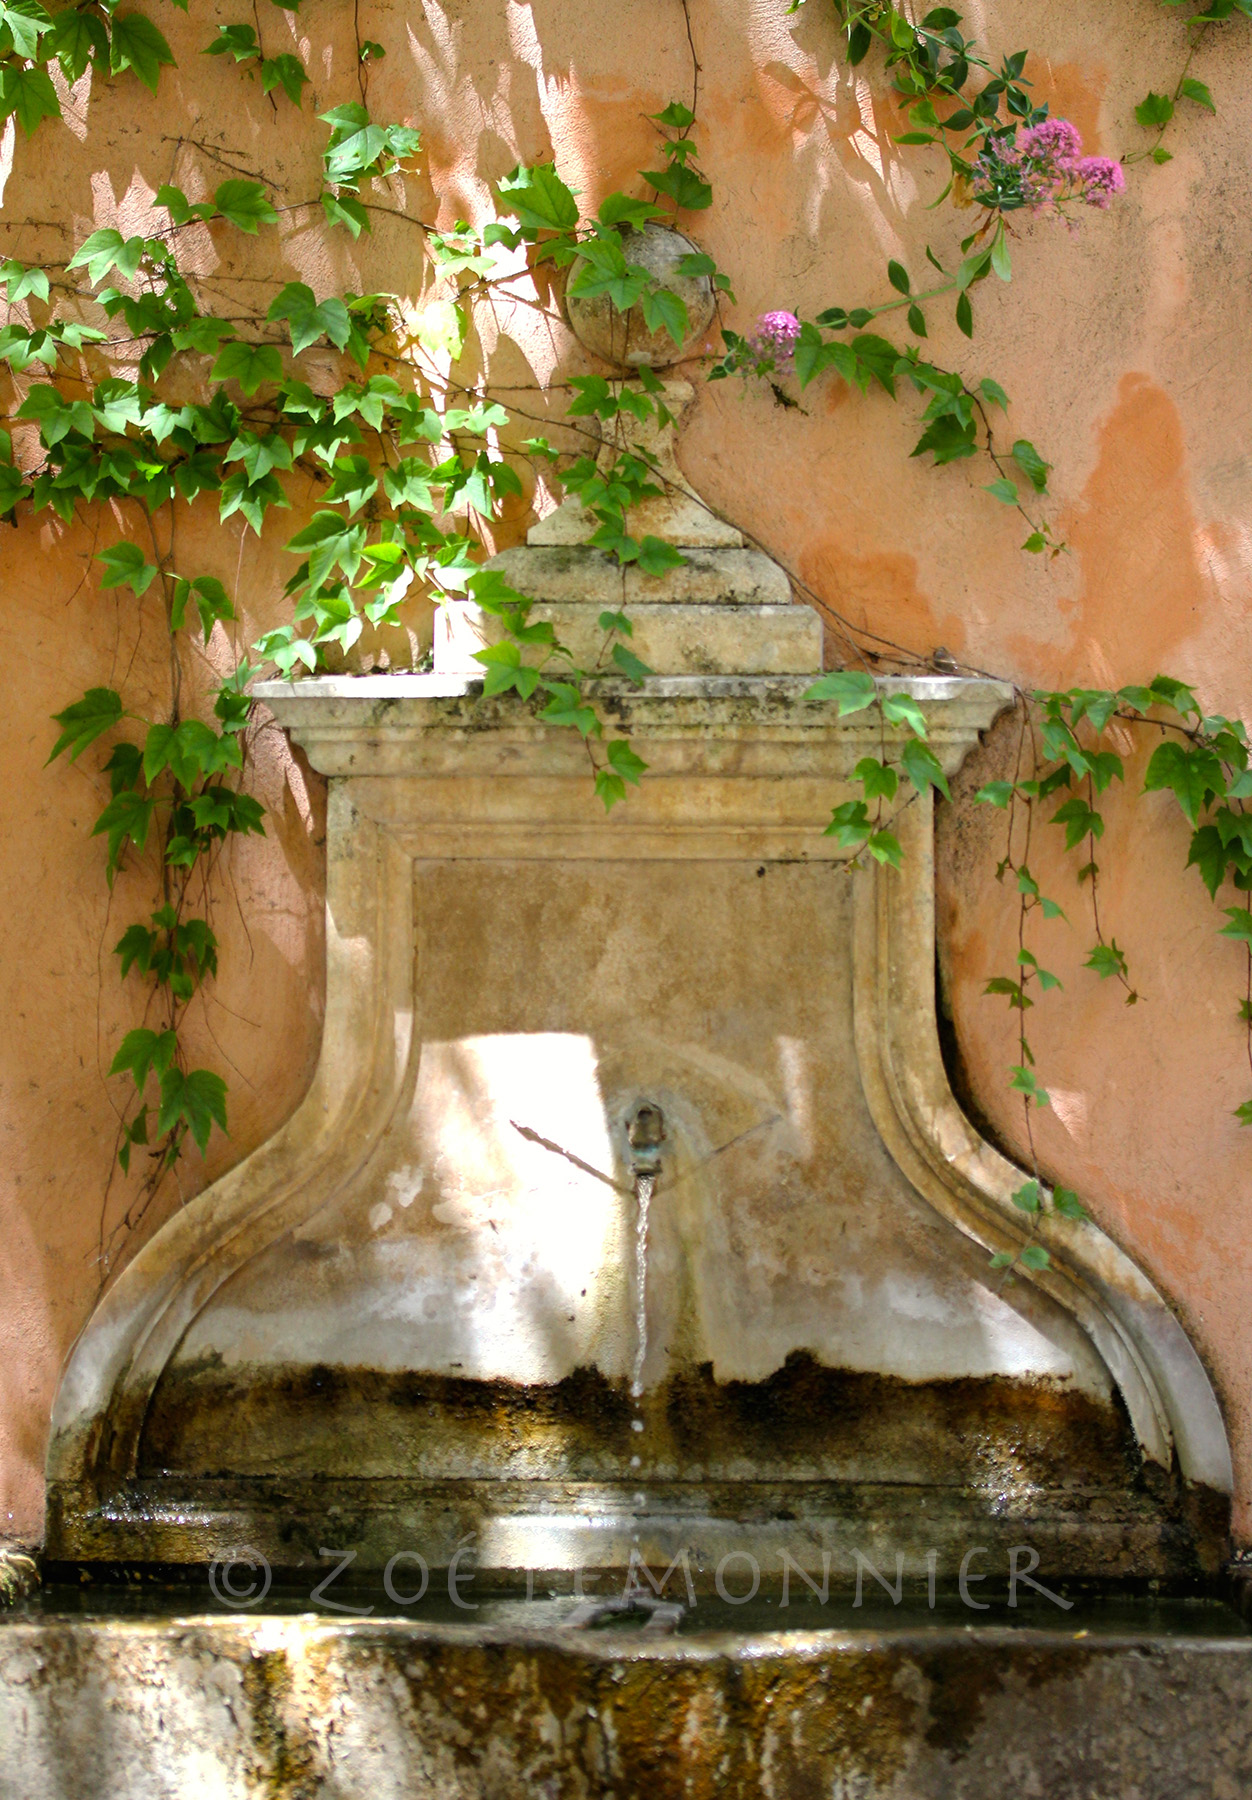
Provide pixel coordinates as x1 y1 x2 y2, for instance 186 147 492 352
0 1616 1252 1800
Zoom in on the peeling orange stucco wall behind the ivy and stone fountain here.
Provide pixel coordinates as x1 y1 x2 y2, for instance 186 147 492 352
0 0 1252 1539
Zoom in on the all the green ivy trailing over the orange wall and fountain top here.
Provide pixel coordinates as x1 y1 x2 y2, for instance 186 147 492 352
0 0 1252 1296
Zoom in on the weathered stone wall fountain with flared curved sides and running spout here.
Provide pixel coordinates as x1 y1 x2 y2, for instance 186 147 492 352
9 243 1248 1800
